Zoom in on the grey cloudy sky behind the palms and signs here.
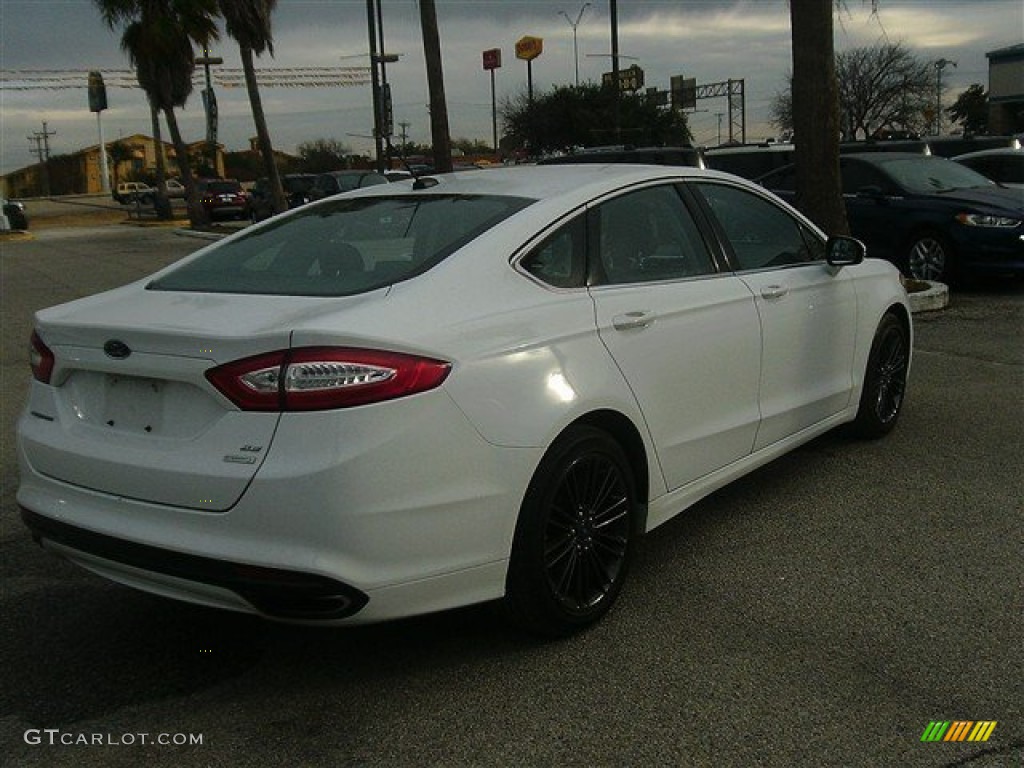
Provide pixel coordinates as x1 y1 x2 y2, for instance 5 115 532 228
0 0 1024 172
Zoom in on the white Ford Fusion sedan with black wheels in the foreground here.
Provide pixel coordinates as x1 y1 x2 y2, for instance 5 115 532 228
17 165 911 634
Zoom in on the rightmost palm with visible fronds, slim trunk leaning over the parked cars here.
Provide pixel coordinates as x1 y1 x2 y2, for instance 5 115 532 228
217 0 288 213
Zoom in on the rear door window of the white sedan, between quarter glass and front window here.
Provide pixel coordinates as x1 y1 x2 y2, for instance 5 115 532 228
593 184 715 285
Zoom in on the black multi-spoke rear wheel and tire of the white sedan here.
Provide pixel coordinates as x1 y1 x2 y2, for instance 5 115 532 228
505 426 639 636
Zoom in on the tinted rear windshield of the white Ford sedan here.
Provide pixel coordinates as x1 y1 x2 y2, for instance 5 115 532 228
147 195 532 296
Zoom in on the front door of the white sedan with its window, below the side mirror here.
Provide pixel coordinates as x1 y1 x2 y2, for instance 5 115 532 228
693 181 857 450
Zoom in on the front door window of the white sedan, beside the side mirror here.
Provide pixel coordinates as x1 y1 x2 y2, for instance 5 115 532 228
694 183 824 271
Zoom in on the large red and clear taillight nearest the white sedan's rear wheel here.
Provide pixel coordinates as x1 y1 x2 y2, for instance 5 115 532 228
206 347 452 411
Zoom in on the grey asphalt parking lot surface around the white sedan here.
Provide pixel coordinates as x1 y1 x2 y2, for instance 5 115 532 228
0 225 1024 768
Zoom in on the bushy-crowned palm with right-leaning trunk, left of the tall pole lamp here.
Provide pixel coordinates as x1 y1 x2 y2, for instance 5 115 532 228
93 0 218 226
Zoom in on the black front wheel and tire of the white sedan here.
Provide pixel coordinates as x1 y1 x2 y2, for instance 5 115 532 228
853 314 910 437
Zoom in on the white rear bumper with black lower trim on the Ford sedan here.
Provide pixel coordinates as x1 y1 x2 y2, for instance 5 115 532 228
17 391 541 624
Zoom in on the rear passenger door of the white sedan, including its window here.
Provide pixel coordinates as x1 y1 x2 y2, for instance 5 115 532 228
588 183 761 489
